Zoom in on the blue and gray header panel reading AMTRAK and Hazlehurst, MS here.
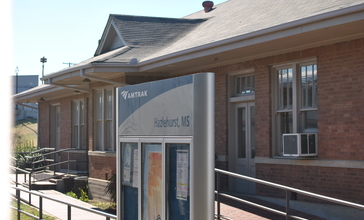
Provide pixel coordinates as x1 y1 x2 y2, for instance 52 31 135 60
118 75 195 135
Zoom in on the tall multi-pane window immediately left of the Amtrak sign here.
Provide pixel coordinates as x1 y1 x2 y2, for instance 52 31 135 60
94 88 115 151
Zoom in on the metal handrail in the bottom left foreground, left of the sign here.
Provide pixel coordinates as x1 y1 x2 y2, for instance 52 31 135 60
11 186 117 220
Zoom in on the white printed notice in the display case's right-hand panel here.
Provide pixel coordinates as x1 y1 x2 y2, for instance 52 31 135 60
176 150 188 201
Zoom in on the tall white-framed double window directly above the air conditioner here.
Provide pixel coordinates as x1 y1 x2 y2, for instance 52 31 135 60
272 61 317 156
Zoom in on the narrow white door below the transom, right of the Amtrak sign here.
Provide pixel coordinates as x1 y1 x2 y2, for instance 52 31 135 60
235 102 255 194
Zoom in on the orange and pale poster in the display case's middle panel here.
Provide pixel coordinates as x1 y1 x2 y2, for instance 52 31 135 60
143 144 163 220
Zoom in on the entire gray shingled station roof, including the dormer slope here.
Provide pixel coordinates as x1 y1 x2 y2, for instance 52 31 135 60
65 0 364 68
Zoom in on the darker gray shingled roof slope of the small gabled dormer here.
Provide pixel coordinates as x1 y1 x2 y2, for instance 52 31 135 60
75 14 206 67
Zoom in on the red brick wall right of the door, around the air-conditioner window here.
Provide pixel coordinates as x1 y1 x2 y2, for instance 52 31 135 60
256 39 364 204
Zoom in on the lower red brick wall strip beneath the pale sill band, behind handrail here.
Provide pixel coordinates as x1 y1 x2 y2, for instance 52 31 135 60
256 164 364 204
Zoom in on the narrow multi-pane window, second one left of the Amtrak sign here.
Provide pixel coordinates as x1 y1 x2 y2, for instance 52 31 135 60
72 100 85 149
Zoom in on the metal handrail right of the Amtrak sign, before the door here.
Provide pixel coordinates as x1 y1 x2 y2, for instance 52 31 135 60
215 168 364 219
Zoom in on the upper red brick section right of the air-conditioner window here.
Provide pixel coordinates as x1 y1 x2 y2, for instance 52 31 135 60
318 39 364 160
